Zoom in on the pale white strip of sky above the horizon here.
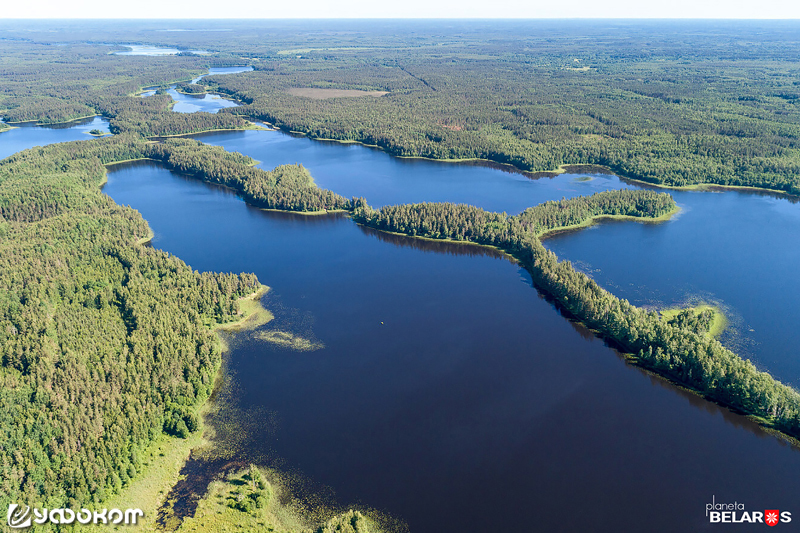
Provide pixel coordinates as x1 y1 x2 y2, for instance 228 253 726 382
0 0 800 19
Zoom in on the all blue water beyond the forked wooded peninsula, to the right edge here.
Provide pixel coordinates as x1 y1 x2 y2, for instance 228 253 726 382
196 131 800 386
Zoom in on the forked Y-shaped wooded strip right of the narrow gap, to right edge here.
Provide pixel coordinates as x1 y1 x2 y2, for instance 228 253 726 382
353 191 800 437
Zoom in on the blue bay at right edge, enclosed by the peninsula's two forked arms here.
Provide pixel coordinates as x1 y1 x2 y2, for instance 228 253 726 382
545 185 800 387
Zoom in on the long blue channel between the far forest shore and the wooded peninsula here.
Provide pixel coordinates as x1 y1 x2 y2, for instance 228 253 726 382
194 130 628 214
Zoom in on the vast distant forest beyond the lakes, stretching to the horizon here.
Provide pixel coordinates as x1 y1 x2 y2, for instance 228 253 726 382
0 21 800 194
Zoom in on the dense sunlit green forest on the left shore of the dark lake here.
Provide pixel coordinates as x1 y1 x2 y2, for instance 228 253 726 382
0 136 259 508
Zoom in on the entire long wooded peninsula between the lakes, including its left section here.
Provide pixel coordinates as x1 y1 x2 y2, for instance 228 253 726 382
98 131 800 437
